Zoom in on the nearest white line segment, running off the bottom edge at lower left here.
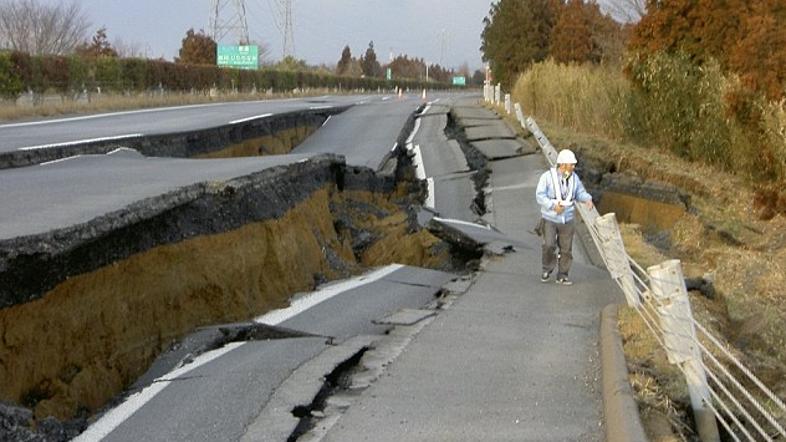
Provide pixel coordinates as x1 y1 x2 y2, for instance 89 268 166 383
74 342 244 442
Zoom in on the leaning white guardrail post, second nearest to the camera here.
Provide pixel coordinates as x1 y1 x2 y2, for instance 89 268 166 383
595 213 641 308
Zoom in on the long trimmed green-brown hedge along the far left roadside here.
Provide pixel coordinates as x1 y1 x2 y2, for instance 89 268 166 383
0 52 451 99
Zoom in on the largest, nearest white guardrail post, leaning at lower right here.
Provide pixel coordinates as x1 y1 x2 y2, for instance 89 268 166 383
647 259 720 442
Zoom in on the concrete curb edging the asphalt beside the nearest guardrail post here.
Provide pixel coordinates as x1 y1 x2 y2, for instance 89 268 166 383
600 304 648 442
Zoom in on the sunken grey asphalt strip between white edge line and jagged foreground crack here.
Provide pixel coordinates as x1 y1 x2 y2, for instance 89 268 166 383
98 267 454 442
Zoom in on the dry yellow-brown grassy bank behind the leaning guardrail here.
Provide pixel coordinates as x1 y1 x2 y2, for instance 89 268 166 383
544 121 786 435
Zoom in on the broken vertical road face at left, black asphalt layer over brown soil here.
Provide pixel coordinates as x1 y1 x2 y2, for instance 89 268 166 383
0 113 472 440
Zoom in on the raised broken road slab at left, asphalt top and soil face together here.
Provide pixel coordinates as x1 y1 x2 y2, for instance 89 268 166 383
0 135 466 438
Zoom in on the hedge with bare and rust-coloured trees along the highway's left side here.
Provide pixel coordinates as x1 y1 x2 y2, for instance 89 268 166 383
0 0 460 99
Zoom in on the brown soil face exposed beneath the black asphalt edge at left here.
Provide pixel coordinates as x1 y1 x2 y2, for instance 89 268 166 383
0 186 448 419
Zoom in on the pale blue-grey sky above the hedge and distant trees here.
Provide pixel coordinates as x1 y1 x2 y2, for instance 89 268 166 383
55 0 491 69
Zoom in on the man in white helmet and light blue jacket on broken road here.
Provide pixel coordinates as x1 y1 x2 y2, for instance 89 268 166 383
535 149 592 285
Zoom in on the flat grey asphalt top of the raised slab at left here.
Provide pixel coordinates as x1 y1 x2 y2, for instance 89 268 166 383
0 151 310 239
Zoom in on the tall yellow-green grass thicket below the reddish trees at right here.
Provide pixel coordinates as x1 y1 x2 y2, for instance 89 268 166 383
512 54 786 183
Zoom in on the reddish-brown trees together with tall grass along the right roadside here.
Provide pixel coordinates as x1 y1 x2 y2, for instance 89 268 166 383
481 0 786 188
